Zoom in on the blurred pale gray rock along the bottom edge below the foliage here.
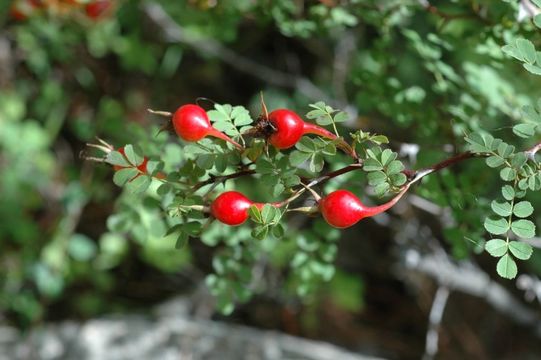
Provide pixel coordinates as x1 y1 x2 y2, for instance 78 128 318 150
0 299 386 360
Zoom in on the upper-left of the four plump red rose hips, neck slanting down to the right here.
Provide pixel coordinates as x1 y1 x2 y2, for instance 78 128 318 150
173 104 243 150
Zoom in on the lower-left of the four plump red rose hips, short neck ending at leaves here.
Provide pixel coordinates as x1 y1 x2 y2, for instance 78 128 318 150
210 191 265 226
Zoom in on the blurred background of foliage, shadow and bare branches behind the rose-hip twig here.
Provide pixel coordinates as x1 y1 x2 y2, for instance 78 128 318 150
0 0 541 359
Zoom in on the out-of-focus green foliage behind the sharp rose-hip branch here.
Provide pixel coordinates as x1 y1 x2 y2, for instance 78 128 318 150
0 0 541 326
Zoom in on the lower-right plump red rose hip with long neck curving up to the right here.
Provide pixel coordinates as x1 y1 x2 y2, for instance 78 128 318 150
319 188 407 228
